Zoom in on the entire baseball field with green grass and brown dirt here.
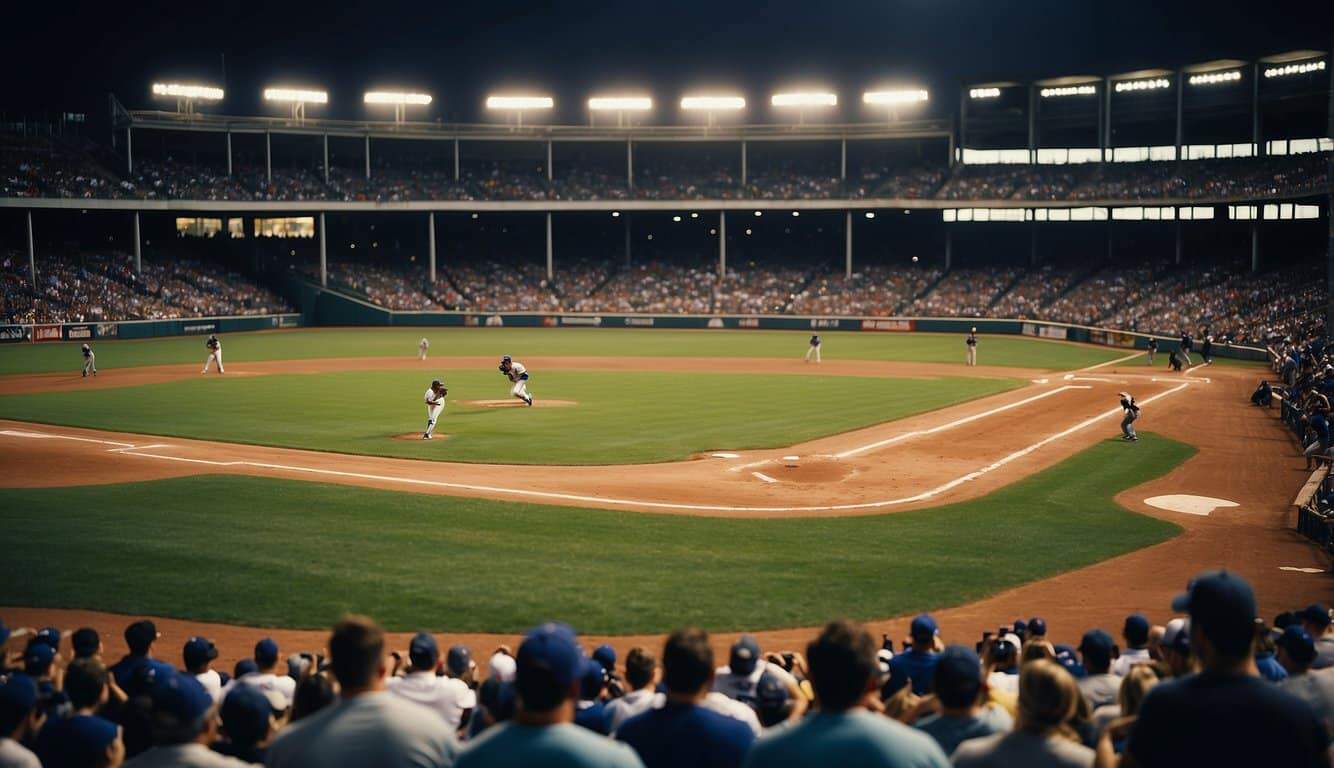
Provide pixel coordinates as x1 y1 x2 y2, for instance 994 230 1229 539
0 328 1318 656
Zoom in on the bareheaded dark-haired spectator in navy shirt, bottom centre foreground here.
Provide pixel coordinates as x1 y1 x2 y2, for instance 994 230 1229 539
616 628 755 768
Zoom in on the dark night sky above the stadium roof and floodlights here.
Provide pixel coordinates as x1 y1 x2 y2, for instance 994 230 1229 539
0 0 1334 123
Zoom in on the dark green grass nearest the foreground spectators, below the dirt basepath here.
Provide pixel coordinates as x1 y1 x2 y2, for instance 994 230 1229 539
0 435 1193 633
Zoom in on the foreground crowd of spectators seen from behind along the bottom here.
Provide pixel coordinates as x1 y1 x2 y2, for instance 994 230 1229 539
0 571 1334 768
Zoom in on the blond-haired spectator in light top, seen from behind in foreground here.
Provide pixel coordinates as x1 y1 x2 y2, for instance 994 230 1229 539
954 660 1094 768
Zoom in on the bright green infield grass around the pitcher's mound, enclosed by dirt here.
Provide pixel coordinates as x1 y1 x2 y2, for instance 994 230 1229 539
0 369 1023 464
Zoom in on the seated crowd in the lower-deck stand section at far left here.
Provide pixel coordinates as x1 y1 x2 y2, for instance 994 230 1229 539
0 251 291 324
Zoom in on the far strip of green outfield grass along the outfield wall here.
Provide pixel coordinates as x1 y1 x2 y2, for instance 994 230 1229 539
0 328 1127 375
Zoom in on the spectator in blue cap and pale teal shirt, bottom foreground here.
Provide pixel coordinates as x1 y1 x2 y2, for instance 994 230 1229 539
458 623 642 768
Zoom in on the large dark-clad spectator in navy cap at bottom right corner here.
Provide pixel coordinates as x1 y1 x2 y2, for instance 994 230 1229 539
1098 571 1330 768
